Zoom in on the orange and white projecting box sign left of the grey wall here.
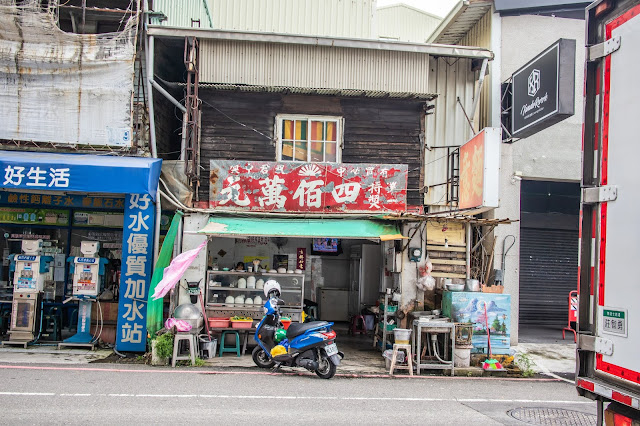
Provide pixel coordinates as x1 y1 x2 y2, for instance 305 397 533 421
458 127 502 214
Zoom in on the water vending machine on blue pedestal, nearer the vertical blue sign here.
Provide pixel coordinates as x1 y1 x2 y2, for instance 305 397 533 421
59 241 108 346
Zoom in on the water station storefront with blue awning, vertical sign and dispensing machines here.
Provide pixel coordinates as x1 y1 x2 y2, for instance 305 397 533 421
0 151 162 352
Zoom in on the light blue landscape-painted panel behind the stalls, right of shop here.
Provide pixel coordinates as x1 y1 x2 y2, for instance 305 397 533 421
442 291 511 355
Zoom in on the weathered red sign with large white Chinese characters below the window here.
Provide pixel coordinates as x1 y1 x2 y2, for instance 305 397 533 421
209 160 408 213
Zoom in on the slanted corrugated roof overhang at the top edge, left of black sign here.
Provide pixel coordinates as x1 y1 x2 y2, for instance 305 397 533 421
427 0 492 44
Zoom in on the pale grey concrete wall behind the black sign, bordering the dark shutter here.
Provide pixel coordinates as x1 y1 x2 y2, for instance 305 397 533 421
488 15 585 345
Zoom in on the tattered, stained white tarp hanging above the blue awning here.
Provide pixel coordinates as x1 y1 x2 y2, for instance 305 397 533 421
0 0 137 147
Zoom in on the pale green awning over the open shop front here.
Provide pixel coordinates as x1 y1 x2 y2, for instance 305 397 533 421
198 217 403 240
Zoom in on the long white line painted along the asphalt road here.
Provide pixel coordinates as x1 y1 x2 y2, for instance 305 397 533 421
0 392 593 405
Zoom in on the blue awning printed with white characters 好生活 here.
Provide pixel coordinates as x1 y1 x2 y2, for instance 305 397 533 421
0 151 162 200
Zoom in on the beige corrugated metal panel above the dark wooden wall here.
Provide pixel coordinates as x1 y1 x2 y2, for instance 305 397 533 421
200 40 436 93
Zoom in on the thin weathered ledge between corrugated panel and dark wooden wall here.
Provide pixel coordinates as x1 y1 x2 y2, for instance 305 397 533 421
195 83 438 100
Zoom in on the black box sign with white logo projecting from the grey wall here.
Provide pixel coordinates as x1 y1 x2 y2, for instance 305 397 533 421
511 38 576 138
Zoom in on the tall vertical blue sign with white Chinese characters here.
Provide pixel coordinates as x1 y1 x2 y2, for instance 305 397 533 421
116 194 155 352
